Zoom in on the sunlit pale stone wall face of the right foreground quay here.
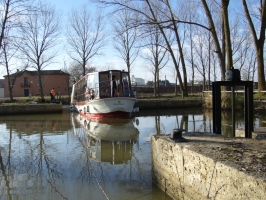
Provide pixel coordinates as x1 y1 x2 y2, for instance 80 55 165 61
152 136 266 200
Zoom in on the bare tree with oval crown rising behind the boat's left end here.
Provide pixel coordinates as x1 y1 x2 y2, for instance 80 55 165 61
67 6 106 75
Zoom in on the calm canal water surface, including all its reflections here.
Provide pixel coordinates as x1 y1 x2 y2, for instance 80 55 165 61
0 108 266 200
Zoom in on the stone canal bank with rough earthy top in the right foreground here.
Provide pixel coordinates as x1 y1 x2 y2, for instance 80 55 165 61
152 132 266 200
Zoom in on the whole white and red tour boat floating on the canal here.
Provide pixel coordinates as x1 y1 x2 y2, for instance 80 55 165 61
71 70 137 118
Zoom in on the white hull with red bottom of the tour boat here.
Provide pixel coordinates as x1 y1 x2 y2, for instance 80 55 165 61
72 97 137 117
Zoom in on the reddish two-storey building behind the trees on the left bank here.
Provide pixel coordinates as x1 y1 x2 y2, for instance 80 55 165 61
4 70 69 97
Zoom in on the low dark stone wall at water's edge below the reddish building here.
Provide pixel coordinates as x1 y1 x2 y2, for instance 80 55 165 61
0 103 62 115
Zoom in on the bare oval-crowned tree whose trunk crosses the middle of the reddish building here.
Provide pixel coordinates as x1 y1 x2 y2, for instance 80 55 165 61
16 3 61 101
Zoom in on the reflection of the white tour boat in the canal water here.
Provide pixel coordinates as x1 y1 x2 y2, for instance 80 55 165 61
72 113 139 164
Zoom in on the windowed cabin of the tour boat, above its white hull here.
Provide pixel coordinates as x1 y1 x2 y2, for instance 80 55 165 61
72 70 132 102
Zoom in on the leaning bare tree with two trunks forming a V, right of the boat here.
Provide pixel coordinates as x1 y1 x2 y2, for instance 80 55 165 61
95 0 188 95
